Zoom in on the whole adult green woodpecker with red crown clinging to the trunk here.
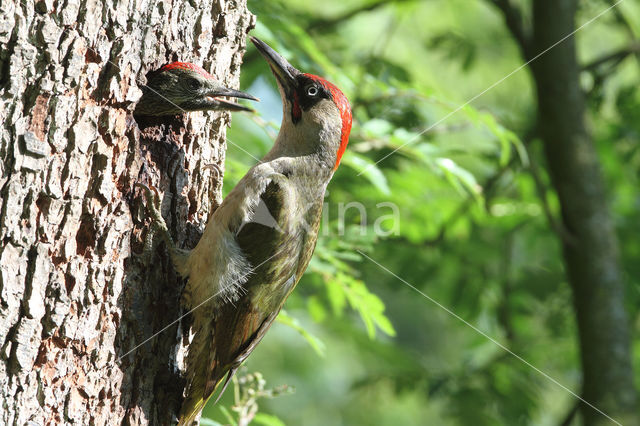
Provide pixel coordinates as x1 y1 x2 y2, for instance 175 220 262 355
139 37 351 425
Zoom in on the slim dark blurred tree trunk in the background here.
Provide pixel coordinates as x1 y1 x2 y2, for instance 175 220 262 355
531 0 638 425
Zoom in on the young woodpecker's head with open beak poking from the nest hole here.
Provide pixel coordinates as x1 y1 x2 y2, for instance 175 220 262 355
135 62 258 115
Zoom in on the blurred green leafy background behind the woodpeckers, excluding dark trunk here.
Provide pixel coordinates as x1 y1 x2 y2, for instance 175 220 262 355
203 0 640 426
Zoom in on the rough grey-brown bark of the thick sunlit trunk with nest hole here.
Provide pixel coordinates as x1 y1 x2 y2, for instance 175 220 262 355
0 0 254 425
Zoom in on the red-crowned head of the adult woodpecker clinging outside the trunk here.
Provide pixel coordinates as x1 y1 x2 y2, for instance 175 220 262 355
251 37 352 172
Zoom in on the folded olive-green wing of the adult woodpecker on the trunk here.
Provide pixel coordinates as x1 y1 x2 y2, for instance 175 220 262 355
181 174 322 424
